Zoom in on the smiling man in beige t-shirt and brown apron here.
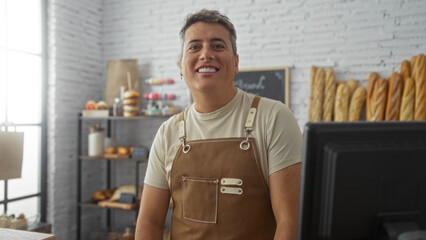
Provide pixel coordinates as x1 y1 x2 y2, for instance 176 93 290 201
136 10 302 240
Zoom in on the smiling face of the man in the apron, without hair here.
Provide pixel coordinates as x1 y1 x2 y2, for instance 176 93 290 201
180 22 238 93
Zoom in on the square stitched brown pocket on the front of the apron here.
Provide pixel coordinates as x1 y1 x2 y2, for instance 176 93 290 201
182 177 219 223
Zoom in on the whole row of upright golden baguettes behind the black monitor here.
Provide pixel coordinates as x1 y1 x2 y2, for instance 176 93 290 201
308 54 426 122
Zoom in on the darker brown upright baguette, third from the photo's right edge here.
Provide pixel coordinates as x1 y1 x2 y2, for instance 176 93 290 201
385 72 402 121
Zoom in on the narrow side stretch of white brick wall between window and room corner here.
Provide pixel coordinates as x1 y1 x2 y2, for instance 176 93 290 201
47 0 104 240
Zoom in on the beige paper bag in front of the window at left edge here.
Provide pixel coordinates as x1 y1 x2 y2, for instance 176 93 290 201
0 131 24 180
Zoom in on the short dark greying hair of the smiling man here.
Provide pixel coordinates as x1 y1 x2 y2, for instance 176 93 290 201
180 9 237 54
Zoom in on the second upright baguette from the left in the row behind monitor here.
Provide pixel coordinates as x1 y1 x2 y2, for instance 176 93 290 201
322 67 336 122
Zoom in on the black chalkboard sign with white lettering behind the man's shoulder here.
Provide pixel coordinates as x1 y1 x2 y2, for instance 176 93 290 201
234 67 290 106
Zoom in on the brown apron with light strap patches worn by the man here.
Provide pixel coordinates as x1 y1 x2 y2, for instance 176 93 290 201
171 97 276 240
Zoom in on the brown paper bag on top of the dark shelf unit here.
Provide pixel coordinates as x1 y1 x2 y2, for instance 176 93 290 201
105 59 140 106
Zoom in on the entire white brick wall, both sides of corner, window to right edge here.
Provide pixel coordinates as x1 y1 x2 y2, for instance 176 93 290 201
48 0 426 239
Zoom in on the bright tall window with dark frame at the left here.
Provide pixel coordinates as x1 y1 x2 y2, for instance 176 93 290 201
0 0 47 222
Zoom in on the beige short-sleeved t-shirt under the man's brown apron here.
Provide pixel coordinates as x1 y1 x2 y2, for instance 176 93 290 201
145 89 302 189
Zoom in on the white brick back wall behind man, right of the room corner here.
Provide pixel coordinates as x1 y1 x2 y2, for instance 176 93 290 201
103 0 426 128
